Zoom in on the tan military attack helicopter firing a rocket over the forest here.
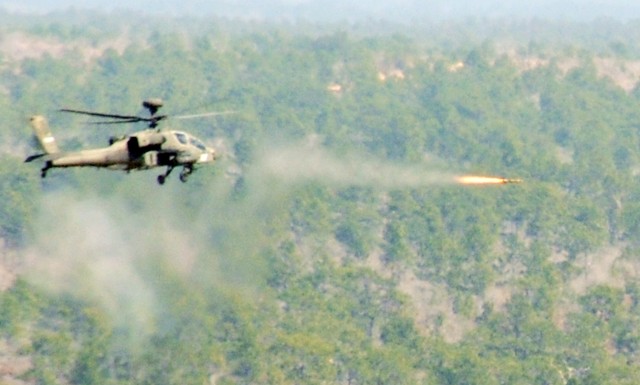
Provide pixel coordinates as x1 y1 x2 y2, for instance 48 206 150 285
25 99 228 185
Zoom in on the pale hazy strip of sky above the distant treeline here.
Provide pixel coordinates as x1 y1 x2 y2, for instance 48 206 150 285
0 0 640 21
